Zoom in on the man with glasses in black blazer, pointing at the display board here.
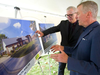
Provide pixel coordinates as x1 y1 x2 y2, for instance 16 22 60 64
36 6 83 75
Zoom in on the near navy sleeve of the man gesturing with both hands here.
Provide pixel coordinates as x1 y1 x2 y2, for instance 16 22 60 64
68 32 100 75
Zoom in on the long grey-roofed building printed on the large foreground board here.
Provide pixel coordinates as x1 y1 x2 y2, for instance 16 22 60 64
2 35 32 55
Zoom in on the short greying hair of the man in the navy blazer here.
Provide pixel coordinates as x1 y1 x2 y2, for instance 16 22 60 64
77 1 98 19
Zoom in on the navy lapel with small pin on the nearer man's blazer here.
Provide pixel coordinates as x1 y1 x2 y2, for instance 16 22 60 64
74 22 99 48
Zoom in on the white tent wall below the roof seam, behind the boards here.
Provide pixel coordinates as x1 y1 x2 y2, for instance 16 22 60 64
0 6 66 44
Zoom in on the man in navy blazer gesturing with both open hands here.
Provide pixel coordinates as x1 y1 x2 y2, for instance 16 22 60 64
50 1 100 75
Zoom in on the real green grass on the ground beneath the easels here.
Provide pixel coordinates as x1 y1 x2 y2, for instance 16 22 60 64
27 55 69 75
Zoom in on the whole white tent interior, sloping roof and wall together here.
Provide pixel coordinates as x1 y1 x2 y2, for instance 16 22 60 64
0 0 100 44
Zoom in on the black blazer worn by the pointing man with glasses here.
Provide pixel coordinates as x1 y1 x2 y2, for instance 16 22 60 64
43 20 83 46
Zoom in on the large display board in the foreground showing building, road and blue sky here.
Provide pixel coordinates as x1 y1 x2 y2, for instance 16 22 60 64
0 17 42 75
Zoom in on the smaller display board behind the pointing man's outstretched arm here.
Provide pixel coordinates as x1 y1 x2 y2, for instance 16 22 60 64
39 23 57 53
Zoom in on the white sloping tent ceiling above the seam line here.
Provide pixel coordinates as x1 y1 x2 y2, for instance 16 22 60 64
0 0 100 16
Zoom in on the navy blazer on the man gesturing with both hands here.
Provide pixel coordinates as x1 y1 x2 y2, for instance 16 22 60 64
64 21 100 75
